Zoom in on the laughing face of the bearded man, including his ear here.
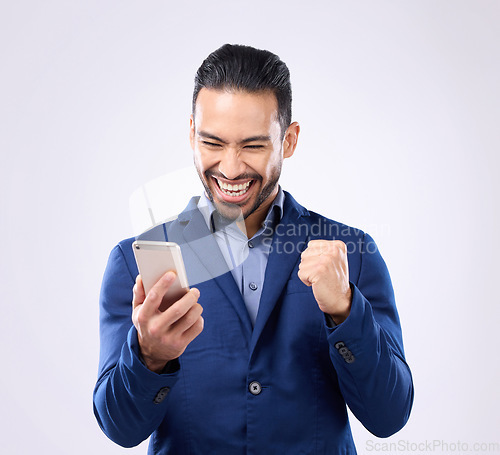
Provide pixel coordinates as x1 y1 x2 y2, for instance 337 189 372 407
190 88 298 223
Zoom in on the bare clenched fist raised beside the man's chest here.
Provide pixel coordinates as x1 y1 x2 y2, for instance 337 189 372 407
298 240 352 324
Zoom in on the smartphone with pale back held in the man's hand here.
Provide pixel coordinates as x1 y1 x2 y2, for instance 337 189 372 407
132 240 189 311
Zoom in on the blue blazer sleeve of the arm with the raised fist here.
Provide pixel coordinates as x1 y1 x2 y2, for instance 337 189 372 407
325 234 413 437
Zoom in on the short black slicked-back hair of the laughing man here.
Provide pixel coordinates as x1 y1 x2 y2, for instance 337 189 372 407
193 44 292 137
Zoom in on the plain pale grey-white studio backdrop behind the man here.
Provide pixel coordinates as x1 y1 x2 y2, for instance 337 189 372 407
0 0 500 454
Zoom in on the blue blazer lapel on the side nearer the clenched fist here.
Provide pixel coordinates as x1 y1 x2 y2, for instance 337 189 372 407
250 191 309 352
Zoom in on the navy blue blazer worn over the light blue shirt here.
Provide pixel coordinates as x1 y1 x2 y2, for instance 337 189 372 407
94 192 413 455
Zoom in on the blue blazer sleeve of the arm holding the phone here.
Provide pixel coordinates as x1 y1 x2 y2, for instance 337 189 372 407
94 245 179 447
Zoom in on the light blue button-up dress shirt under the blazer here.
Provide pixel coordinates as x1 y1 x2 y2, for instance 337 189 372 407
198 187 285 325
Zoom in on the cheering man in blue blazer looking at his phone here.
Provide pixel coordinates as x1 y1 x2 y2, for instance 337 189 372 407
94 45 413 455
